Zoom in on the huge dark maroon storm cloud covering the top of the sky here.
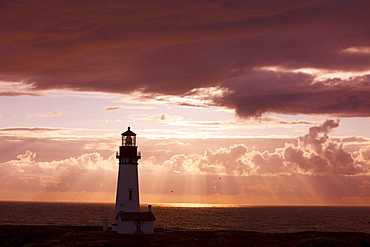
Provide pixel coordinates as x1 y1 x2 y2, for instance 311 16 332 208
0 0 370 117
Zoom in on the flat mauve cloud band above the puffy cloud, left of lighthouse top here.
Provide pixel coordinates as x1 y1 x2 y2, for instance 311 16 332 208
0 133 115 164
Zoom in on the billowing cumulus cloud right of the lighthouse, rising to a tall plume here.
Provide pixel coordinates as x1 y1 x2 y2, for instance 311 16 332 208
144 119 370 176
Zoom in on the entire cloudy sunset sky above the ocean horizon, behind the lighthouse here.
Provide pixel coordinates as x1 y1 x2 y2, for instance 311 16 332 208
0 0 370 206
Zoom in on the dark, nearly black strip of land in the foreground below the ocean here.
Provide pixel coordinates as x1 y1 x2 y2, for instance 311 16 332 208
0 226 370 247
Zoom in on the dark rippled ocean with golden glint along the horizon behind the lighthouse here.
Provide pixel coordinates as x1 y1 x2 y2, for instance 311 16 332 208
0 201 370 233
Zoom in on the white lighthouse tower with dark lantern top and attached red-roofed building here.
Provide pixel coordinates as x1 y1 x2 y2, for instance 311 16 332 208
112 127 155 234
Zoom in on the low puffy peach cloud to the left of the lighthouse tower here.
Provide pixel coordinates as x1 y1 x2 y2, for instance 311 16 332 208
0 150 116 192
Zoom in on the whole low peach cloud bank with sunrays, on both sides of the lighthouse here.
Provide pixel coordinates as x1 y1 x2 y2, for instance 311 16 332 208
0 119 370 204
